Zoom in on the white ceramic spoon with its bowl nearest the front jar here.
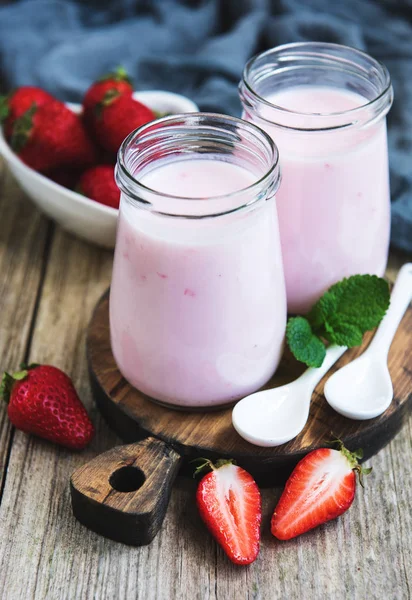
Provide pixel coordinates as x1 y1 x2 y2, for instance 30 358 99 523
232 346 347 447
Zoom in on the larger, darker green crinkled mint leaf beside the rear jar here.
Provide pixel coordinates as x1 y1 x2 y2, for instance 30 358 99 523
307 275 390 348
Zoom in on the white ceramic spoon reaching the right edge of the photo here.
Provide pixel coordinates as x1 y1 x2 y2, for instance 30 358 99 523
324 263 412 421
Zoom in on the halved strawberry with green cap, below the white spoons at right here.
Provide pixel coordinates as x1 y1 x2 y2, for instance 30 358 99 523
271 443 371 540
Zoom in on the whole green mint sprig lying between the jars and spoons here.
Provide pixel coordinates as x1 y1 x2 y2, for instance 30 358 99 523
286 275 390 367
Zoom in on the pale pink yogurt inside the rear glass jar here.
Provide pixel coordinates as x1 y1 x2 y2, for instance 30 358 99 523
249 86 390 313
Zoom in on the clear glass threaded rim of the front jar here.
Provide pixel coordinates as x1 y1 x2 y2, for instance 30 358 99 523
115 112 280 218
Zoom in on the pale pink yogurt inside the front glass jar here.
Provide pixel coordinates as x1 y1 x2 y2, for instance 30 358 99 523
110 155 286 408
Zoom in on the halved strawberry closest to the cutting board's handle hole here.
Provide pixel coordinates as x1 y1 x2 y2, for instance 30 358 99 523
196 460 262 565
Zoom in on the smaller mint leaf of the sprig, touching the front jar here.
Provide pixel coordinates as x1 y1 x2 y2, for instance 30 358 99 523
286 317 326 367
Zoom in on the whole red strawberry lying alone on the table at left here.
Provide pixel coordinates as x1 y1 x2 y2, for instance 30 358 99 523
0 365 94 450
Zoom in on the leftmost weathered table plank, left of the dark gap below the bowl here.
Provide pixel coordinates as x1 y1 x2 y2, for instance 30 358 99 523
0 160 49 501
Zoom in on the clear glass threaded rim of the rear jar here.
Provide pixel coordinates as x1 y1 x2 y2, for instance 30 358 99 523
240 42 392 130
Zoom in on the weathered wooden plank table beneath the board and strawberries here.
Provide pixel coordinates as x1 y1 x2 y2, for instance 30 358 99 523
0 161 412 600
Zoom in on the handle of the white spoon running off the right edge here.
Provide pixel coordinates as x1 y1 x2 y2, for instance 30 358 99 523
368 263 412 356
